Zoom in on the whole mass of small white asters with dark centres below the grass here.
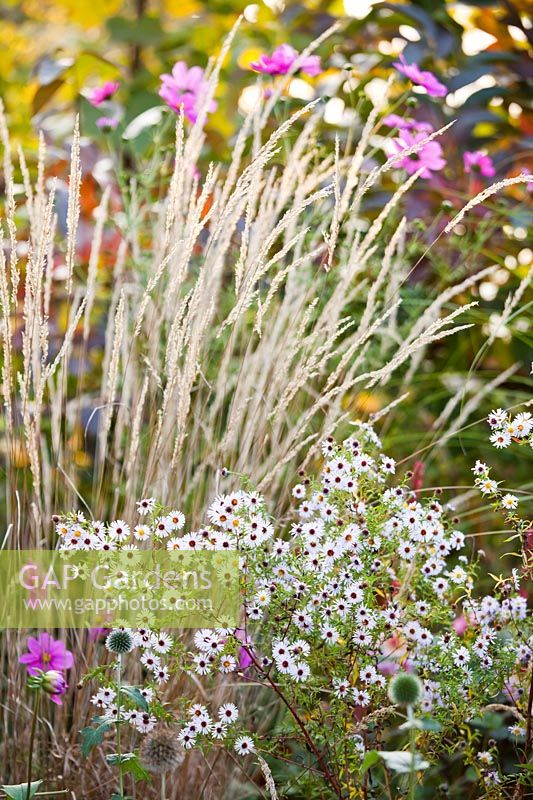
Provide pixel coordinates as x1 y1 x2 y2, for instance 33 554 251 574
68 417 533 788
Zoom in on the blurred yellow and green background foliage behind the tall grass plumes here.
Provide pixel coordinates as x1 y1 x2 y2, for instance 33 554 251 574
0 0 533 552
